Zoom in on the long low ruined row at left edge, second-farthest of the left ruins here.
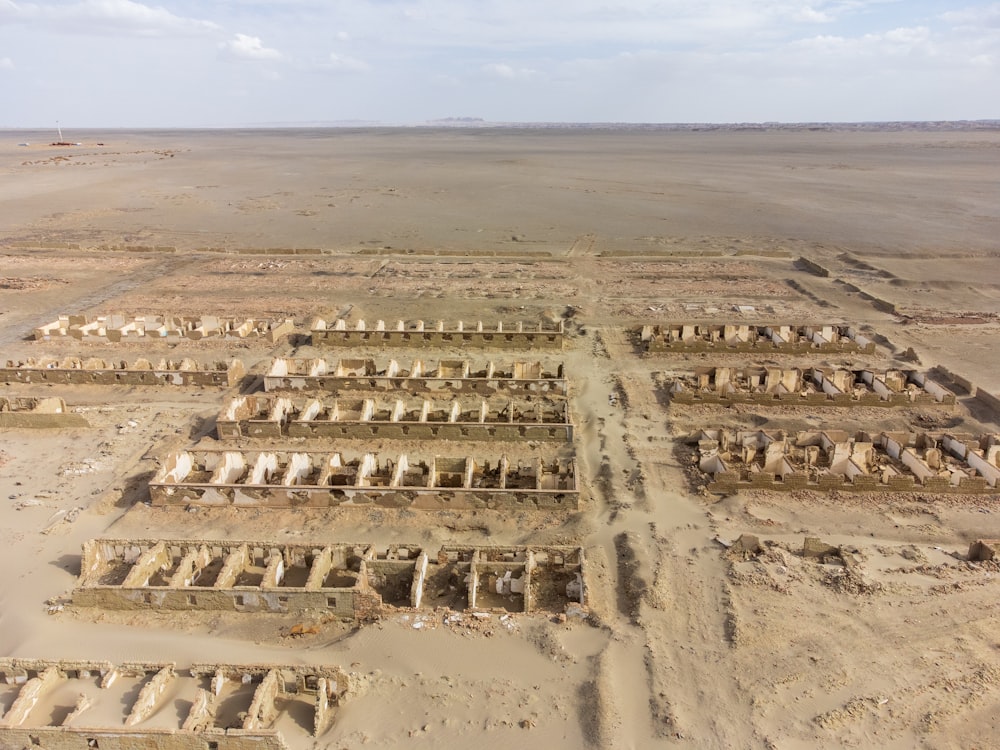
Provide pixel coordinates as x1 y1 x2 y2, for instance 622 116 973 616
0 357 246 387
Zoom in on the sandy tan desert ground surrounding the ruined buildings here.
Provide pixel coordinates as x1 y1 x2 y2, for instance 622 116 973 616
0 126 1000 750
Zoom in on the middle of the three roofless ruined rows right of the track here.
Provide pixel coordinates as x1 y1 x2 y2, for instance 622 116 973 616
668 367 955 407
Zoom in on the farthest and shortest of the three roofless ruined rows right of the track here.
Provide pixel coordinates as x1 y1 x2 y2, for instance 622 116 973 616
637 323 875 354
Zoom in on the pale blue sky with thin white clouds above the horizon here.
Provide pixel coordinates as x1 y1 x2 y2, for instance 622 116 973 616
0 0 1000 128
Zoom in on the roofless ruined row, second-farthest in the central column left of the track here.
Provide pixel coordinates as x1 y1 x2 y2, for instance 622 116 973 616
264 358 566 396
